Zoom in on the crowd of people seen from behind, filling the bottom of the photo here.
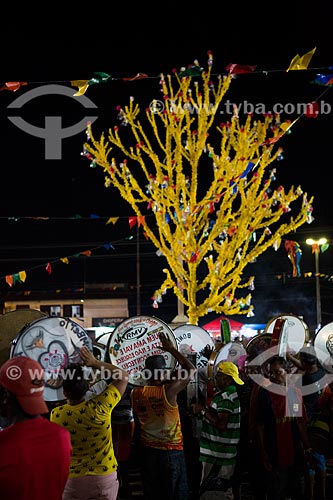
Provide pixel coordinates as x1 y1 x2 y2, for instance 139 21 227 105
0 333 333 500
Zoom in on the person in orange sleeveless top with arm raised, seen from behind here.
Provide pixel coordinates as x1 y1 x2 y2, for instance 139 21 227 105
131 332 196 500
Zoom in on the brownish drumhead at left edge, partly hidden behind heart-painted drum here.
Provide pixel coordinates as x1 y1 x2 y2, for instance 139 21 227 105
0 309 47 365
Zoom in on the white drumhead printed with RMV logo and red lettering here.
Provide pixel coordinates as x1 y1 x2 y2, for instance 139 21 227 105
106 316 177 386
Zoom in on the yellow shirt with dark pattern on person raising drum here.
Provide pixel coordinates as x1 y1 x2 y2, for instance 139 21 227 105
50 384 121 477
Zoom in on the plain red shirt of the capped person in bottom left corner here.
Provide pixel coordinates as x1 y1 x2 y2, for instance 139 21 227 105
0 417 72 500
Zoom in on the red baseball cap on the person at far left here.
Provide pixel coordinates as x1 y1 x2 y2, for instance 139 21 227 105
0 356 49 415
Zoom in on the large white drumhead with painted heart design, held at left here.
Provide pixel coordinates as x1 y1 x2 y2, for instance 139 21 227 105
11 317 92 401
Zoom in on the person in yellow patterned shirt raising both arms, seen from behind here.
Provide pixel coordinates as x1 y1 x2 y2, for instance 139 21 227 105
50 346 128 500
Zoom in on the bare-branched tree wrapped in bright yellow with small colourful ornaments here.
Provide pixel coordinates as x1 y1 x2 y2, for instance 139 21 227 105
84 54 312 325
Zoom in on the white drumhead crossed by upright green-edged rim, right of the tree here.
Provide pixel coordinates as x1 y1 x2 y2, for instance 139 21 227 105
265 314 309 357
